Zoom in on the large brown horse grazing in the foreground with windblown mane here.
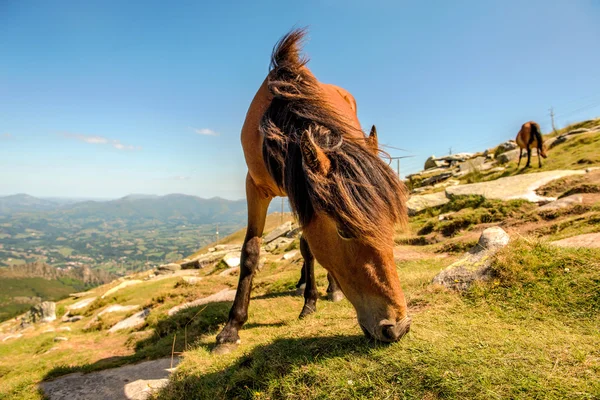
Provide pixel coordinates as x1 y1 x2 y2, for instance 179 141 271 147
213 29 411 353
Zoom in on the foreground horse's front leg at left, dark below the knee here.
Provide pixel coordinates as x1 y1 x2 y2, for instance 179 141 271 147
213 174 271 354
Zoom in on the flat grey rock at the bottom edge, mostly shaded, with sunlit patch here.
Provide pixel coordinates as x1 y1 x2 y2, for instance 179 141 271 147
40 358 179 400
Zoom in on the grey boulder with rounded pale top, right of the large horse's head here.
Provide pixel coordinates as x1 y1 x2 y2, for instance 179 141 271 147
432 227 509 290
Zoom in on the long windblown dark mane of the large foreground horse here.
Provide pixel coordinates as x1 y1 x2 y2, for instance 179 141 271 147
260 29 407 248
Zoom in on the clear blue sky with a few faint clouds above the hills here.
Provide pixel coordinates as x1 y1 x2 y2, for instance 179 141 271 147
0 0 600 199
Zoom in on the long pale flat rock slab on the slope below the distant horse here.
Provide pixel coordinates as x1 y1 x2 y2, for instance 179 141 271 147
448 170 585 203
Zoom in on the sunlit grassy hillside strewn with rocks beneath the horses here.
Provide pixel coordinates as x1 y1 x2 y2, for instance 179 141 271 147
0 117 600 399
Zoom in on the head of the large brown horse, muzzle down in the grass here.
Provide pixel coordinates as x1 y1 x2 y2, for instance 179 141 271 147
300 127 410 342
